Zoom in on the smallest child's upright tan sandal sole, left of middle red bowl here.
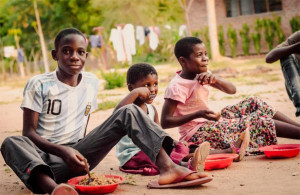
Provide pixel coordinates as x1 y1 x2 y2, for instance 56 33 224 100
192 142 210 173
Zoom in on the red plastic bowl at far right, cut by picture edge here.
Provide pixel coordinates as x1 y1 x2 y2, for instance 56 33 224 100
259 144 300 158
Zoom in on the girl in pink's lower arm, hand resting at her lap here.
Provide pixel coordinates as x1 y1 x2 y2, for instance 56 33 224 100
160 99 220 129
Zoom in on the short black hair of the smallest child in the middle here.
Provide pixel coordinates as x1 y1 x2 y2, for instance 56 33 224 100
127 63 157 84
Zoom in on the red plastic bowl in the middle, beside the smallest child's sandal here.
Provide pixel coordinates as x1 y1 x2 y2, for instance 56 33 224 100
204 154 238 170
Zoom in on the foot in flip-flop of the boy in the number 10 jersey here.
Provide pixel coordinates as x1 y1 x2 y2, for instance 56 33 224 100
158 164 207 185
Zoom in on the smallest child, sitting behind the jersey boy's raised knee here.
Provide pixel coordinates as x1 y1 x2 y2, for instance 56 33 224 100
115 63 210 175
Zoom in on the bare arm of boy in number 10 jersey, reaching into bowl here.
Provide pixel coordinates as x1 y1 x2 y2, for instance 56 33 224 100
23 108 85 172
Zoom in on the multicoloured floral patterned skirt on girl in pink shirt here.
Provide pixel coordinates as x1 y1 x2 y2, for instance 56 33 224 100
189 97 277 154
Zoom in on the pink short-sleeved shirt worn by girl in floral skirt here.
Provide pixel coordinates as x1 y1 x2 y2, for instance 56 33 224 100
164 72 209 141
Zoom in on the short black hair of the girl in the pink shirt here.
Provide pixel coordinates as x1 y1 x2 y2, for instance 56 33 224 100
174 37 203 60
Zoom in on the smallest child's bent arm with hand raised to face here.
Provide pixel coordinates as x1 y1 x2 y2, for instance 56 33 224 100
114 87 150 111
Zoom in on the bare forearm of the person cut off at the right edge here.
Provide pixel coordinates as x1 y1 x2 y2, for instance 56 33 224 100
266 42 300 63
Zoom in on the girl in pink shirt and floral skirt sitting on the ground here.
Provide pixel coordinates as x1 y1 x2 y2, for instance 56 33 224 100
161 37 300 161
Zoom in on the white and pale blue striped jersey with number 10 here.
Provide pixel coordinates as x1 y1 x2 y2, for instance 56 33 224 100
21 71 99 144
